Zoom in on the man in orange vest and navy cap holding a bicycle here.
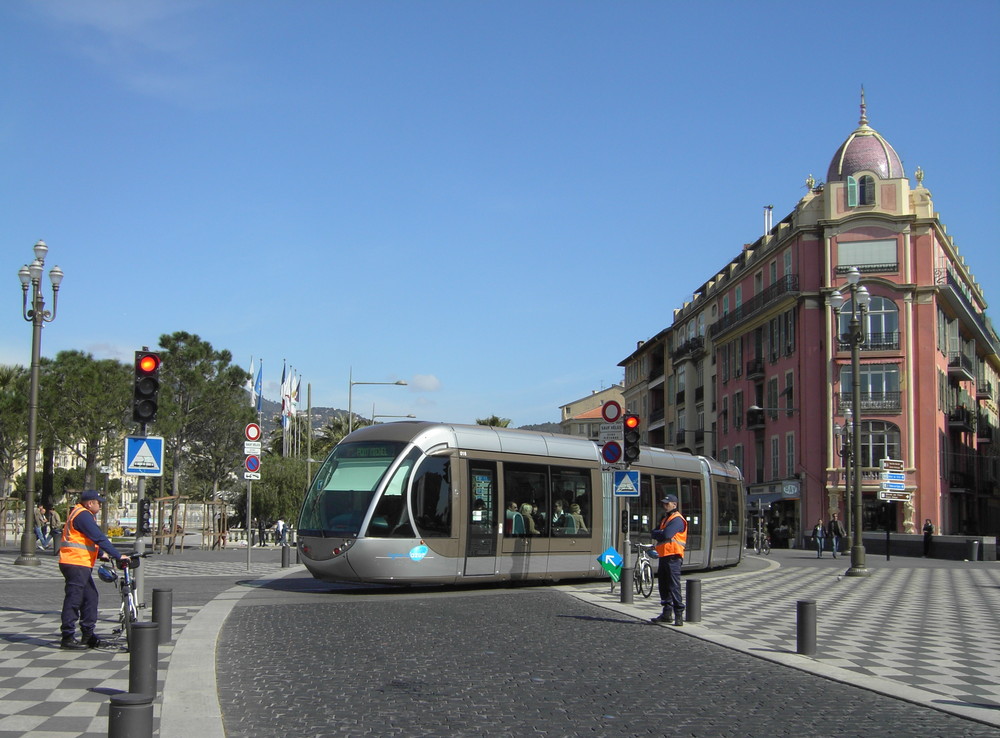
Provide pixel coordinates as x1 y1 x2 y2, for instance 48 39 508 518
59 490 129 651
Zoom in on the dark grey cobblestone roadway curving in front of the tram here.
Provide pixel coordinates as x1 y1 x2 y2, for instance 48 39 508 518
217 587 997 738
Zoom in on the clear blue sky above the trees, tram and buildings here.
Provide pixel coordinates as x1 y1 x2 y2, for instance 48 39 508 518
0 0 1000 425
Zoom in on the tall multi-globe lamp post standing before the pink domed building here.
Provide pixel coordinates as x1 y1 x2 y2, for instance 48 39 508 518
830 267 871 577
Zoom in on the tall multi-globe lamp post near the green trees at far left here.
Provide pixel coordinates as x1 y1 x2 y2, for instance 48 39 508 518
14 241 63 566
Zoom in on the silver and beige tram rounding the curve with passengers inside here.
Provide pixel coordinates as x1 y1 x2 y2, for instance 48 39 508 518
298 422 744 584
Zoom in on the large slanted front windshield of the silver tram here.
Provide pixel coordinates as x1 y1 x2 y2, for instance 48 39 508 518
299 441 405 537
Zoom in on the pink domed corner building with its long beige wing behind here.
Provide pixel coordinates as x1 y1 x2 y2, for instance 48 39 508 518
620 97 1000 543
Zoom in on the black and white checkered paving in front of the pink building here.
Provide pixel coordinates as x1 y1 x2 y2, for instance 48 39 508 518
572 561 1000 725
